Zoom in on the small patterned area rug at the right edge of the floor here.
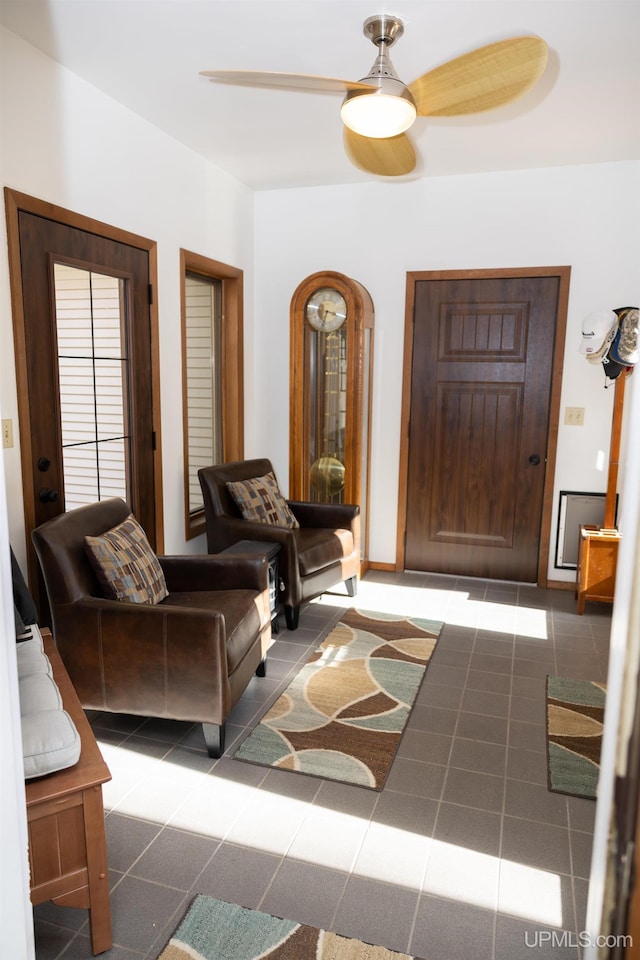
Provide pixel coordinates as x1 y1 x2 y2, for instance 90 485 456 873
547 677 607 800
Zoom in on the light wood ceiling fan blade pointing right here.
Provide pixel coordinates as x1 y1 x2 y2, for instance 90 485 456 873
409 37 549 117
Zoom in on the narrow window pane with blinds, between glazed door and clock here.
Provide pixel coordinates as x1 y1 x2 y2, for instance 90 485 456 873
184 273 222 515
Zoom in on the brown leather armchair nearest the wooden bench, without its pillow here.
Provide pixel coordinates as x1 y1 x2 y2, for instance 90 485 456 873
32 498 271 757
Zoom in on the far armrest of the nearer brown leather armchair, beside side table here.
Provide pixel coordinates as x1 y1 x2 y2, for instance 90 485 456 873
158 556 269 603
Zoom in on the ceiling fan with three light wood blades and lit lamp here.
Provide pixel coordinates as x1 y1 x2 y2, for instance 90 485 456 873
200 14 548 177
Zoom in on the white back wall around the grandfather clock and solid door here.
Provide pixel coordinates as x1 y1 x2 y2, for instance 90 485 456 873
249 163 640 580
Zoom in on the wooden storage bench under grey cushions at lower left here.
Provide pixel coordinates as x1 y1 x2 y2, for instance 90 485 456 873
26 630 112 953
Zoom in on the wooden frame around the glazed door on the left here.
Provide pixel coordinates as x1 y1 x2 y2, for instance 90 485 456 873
4 187 164 584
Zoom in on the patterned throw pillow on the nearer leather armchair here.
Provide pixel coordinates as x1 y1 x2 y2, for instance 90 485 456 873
84 514 169 603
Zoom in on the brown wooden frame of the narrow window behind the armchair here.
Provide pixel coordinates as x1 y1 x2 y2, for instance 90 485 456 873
180 248 244 540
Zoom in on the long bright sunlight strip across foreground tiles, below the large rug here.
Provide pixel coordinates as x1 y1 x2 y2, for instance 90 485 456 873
100 742 563 926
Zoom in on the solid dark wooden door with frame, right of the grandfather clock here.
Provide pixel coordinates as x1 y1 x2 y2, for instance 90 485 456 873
401 268 568 582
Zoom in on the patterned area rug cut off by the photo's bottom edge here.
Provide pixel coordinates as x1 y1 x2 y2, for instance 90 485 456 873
158 895 417 960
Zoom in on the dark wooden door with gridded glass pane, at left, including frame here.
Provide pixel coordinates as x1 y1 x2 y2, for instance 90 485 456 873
7 191 161 623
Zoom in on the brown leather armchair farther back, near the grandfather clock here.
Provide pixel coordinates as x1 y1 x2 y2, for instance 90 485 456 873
198 458 360 630
